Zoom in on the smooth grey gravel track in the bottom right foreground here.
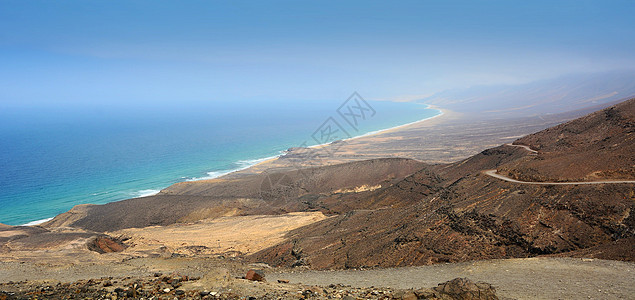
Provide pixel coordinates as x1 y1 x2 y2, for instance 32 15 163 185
267 258 635 299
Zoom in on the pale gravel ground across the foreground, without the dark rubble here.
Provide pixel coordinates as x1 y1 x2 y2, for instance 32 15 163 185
0 258 635 299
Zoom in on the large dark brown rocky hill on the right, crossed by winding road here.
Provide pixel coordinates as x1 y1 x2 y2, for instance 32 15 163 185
252 100 635 269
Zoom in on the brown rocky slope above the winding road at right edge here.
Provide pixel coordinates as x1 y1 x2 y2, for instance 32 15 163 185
501 100 635 181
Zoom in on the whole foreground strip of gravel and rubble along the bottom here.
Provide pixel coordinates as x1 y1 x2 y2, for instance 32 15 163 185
0 257 635 299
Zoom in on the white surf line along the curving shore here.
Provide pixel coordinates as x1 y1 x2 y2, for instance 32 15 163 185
21 103 448 226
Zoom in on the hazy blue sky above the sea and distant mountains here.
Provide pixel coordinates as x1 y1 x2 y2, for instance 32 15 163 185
0 0 635 107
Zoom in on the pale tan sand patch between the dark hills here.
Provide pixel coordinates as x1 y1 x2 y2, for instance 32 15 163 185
115 212 327 254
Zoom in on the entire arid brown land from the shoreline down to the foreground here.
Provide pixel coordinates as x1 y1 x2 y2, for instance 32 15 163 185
0 100 635 299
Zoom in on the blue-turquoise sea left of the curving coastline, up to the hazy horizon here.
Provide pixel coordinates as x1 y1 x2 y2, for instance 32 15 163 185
0 99 440 225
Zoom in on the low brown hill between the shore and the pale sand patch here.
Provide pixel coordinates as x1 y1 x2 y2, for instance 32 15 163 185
43 158 424 232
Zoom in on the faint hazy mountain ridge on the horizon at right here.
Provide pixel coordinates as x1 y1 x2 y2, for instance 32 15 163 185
420 70 635 118
